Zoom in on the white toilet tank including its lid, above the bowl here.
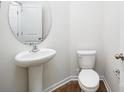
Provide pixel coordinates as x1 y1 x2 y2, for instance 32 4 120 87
77 50 96 69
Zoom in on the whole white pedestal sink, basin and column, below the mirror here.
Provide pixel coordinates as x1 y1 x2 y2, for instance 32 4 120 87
15 49 56 92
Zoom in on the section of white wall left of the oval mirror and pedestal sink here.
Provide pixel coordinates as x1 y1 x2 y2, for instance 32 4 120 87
0 2 29 91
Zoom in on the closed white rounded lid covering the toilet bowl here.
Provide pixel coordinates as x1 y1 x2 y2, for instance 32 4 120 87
79 69 99 88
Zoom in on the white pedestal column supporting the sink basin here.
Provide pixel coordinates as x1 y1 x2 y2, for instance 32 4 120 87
28 65 43 92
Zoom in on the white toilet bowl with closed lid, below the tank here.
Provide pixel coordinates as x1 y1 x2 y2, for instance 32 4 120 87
78 69 99 92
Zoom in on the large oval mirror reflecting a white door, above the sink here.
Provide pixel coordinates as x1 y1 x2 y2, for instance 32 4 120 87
9 1 52 44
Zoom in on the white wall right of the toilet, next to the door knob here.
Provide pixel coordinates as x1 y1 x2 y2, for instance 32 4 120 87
103 2 120 91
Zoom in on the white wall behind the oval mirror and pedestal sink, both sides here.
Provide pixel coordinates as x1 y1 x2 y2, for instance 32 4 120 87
0 2 70 91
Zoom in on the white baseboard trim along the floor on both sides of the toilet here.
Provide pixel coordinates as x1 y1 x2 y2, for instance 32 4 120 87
44 75 111 92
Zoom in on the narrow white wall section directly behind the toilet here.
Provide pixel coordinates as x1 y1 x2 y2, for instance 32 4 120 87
70 2 104 75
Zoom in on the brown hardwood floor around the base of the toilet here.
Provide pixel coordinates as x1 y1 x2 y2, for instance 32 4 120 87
53 80 107 92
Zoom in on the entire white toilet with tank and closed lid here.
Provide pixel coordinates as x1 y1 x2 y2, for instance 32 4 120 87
77 50 99 92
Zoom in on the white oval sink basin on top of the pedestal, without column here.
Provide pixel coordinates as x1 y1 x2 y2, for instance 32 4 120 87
15 49 56 67
